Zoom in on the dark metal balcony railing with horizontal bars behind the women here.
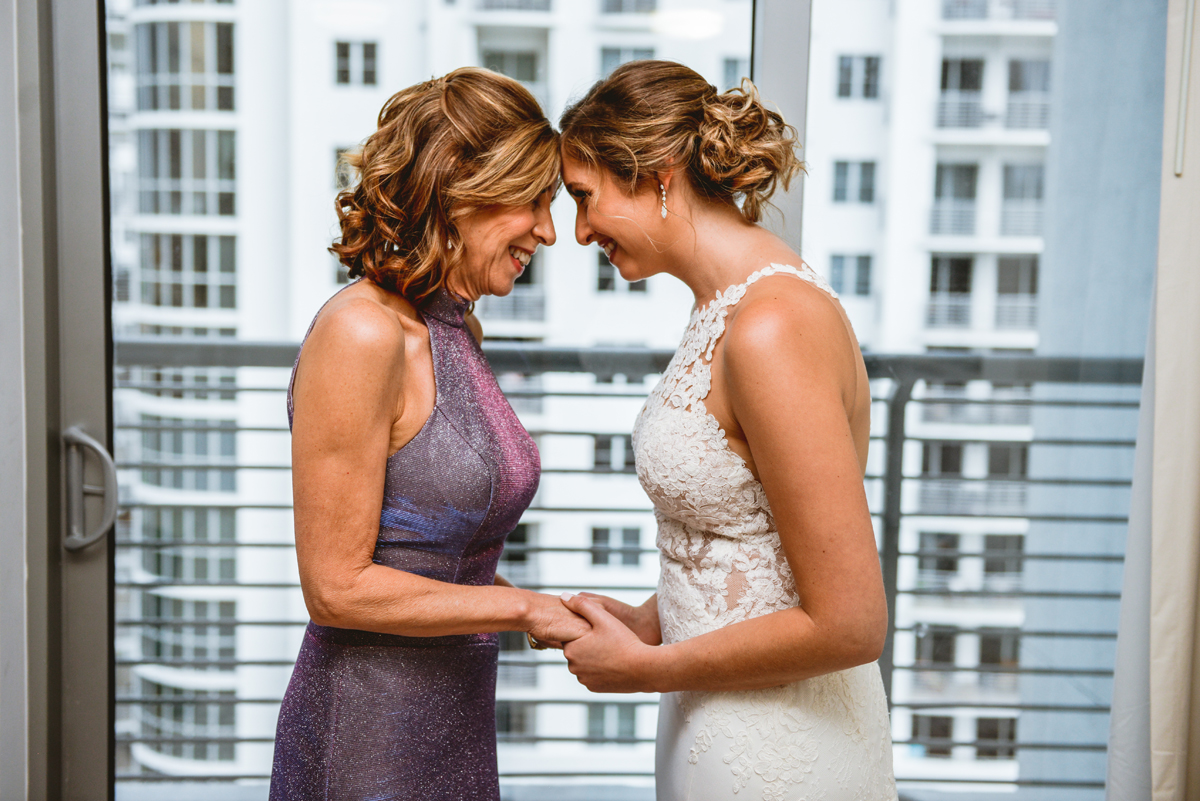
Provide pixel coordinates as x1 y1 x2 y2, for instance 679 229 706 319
115 339 1141 801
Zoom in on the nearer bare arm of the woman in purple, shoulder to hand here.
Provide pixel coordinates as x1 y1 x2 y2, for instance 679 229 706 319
292 299 587 640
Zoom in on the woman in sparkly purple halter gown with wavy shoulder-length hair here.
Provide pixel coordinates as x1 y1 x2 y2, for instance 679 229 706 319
270 68 588 801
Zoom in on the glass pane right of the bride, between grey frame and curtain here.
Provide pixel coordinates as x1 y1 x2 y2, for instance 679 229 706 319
803 0 1164 801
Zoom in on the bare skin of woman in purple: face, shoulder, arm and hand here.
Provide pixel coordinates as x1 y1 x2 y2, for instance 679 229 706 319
292 189 588 642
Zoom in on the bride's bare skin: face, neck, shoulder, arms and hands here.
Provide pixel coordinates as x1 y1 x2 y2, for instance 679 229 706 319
563 156 887 692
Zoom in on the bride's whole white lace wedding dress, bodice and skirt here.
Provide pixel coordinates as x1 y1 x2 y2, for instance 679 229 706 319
634 264 896 801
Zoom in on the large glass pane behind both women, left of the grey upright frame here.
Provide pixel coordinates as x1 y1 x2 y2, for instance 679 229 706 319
106 0 748 801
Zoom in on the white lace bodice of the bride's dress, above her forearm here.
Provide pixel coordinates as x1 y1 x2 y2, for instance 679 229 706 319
634 264 838 643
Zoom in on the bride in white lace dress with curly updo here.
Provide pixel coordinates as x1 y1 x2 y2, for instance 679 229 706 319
562 61 896 801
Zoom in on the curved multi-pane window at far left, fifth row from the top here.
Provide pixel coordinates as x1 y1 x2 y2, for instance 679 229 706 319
142 414 238 492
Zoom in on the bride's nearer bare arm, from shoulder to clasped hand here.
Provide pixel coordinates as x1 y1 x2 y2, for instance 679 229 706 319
566 284 887 692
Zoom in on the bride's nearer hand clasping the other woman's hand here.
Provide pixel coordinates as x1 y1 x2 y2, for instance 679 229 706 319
563 594 659 693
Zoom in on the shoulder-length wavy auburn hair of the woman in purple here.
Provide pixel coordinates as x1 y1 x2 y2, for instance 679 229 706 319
329 67 560 305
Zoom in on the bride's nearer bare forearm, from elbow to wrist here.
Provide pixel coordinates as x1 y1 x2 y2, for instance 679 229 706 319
643 608 881 692
